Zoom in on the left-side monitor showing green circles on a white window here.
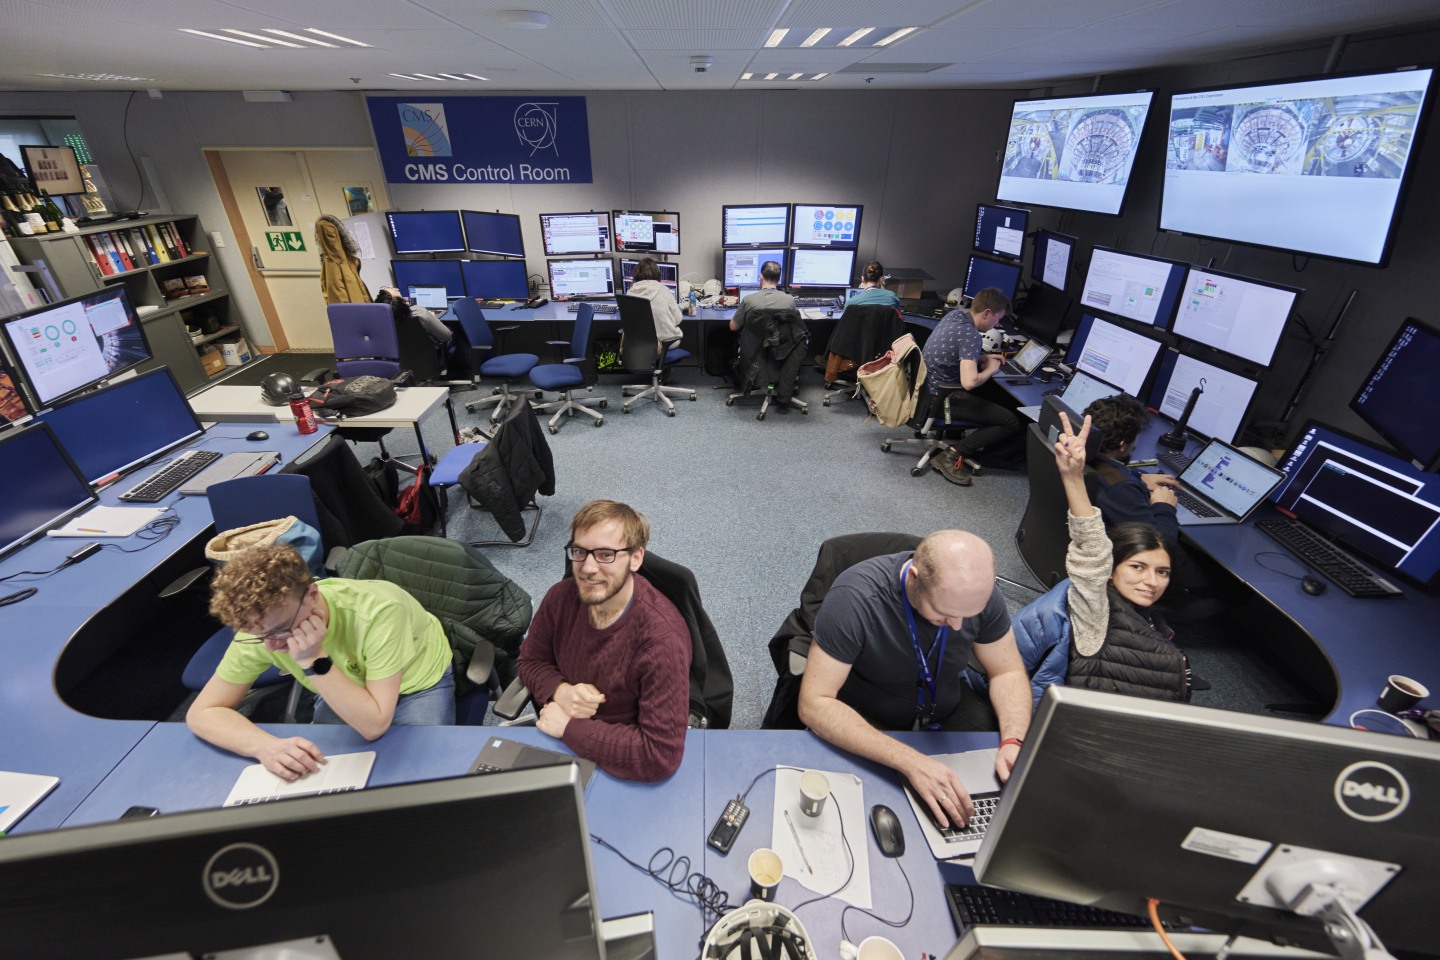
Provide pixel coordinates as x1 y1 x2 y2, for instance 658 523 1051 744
3 286 150 404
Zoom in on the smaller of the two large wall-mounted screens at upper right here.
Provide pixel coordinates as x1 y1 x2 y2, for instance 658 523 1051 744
995 92 1153 214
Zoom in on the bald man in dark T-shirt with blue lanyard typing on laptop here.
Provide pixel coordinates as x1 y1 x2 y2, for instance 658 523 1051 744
799 530 1031 823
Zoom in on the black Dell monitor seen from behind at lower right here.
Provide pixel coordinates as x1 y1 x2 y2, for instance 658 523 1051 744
975 685 1440 954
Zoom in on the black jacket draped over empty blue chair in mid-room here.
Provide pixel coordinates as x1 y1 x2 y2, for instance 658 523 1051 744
459 399 554 543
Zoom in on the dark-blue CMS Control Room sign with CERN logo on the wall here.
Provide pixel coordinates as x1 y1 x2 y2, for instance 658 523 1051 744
366 96 592 184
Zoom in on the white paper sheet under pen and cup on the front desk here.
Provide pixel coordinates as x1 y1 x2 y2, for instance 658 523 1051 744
770 767 871 910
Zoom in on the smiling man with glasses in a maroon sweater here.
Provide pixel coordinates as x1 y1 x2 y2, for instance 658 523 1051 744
520 499 690 780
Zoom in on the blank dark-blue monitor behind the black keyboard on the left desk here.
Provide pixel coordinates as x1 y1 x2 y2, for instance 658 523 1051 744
36 367 204 486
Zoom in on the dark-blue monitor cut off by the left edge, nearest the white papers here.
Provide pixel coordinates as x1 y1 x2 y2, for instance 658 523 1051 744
0 423 95 557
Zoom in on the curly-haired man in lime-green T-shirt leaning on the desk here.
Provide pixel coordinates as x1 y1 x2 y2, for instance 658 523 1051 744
186 544 455 780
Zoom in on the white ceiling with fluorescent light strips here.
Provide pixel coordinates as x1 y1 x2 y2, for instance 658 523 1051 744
0 0 1440 91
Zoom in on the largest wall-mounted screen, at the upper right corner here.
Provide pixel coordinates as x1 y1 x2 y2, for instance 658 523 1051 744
1161 68 1434 263
